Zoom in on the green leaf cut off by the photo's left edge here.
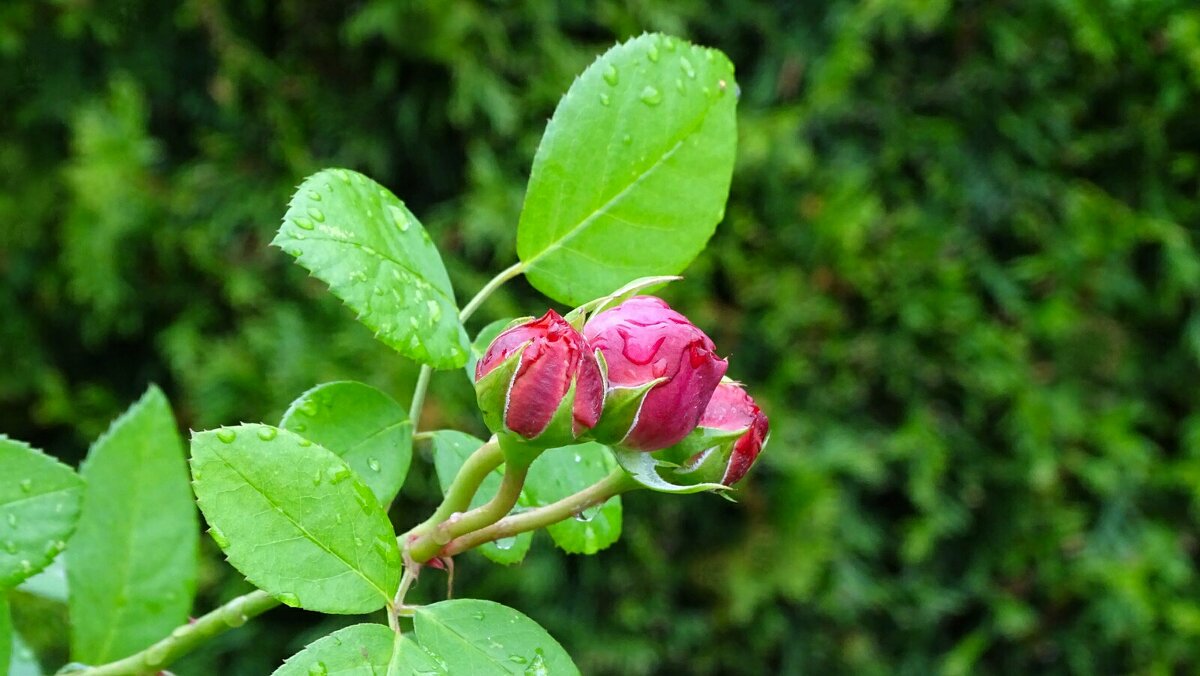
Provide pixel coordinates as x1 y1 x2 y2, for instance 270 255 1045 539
0 435 83 593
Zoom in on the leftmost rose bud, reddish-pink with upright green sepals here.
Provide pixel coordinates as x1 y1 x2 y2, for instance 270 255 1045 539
475 310 604 448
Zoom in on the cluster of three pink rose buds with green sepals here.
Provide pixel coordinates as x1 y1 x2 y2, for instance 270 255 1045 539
475 295 768 485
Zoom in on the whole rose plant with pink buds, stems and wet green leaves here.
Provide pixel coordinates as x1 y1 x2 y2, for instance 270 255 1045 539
0 35 768 676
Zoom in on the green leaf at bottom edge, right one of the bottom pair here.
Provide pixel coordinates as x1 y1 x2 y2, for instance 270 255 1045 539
413 599 580 676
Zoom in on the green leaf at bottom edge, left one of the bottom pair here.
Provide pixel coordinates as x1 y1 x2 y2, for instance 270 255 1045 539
274 624 398 676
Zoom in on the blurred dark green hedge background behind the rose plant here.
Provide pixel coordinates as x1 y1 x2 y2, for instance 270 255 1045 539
0 0 1200 675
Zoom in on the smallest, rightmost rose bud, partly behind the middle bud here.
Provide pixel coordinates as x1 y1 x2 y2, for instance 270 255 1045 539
659 379 770 486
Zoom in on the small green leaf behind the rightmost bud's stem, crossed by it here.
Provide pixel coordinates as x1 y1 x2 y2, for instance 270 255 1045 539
524 442 622 554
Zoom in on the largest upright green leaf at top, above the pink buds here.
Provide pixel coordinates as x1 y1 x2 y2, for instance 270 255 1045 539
517 35 737 305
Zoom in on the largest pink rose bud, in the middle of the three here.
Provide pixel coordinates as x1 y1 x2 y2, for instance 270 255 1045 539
583 295 728 451
